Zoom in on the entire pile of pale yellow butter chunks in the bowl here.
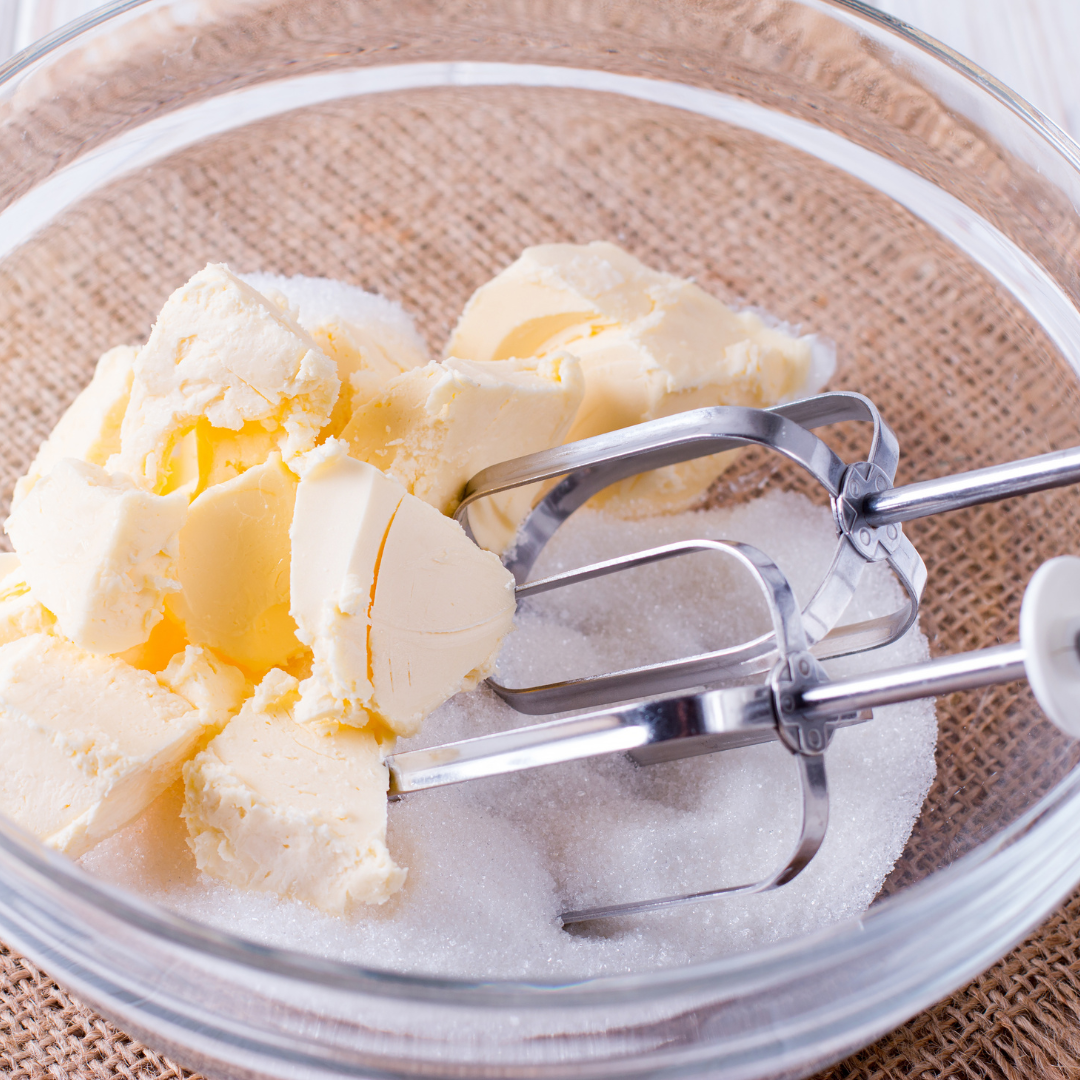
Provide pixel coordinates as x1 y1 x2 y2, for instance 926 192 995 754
0 243 827 914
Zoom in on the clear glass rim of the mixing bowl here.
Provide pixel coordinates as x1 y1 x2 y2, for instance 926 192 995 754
0 0 1080 1010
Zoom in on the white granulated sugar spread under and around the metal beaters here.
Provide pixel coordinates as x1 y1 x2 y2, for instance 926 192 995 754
82 491 936 978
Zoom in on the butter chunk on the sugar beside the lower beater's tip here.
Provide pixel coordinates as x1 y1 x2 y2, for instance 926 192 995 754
184 670 406 915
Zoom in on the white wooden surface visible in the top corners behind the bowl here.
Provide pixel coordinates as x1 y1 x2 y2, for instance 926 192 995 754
0 0 1080 139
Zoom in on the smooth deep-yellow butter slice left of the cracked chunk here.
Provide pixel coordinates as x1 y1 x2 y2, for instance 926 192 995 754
166 451 303 676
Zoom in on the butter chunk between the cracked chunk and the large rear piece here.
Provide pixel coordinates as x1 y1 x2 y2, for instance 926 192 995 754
341 352 584 514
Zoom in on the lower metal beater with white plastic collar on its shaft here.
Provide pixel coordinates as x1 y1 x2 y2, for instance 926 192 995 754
387 541 1080 926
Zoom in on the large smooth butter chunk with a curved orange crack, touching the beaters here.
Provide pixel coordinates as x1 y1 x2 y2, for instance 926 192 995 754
291 440 514 735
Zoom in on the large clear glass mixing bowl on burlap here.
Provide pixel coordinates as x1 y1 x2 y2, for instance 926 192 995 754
0 0 1080 1078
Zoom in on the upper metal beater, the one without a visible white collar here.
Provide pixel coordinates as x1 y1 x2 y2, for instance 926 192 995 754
457 392 1080 714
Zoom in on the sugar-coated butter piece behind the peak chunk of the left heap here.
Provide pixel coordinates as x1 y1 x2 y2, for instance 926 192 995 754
243 273 429 435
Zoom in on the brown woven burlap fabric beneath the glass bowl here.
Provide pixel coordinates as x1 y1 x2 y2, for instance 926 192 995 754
0 48 1080 1078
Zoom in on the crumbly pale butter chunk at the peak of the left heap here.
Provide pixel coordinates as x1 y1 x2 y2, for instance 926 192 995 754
112 264 338 490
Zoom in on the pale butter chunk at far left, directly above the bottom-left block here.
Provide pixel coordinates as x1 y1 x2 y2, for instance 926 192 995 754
5 458 188 653
